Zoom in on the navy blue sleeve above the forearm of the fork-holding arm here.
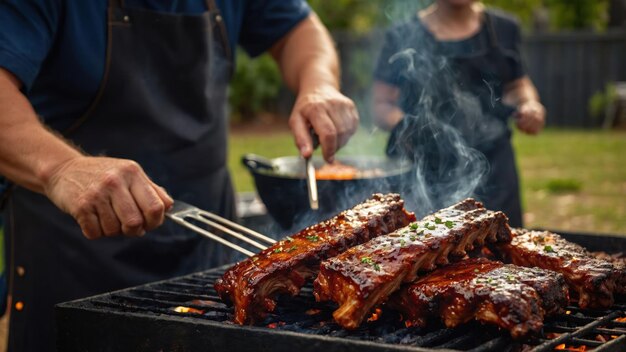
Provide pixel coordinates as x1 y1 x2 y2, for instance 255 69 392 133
0 0 61 91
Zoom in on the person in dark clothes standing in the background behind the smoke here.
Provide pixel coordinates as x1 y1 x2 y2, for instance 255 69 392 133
373 0 545 226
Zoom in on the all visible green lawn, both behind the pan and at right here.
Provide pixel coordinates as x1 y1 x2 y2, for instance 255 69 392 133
229 130 626 234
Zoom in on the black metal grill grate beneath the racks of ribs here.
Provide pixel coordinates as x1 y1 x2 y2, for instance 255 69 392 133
58 268 626 352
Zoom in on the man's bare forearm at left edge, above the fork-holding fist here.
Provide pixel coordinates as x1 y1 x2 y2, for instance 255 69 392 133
0 69 81 193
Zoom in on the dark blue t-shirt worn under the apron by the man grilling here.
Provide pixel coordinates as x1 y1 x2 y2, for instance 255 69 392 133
0 0 310 125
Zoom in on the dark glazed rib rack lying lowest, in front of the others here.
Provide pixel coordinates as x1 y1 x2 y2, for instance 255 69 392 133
387 258 569 338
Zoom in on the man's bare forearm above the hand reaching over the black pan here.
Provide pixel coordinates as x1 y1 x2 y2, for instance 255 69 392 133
271 14 339 92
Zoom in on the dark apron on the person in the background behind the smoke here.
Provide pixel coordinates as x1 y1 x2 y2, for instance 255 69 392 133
387 12 522 227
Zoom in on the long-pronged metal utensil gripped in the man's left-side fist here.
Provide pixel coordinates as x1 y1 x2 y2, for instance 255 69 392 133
165 200 276 257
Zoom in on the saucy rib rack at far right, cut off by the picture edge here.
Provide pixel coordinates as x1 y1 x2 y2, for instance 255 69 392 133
493 229 626 308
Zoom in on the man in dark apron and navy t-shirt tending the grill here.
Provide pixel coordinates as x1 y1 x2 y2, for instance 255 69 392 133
0 0 358 351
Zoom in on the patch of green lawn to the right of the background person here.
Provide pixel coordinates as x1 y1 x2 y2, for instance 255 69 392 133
514 130 626 234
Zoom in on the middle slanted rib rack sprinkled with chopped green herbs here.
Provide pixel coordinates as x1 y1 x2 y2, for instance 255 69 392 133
313 199 511 329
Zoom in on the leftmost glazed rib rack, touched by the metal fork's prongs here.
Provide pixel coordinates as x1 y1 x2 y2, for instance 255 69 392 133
215 194 415 324
